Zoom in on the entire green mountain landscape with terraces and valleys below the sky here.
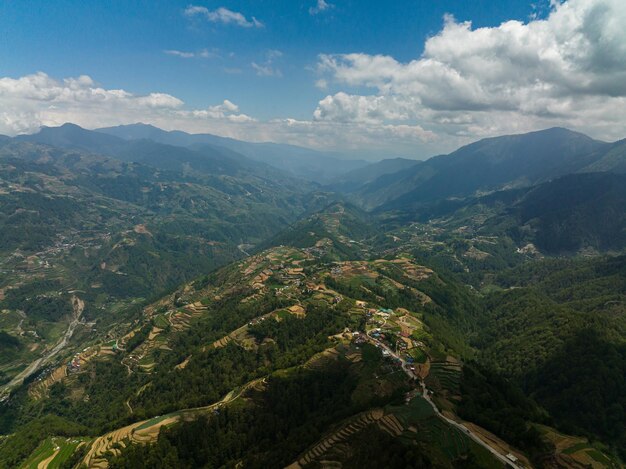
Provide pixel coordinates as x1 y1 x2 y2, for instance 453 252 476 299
0 124 626 468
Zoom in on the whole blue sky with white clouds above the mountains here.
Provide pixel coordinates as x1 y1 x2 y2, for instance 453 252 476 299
0 0 626 159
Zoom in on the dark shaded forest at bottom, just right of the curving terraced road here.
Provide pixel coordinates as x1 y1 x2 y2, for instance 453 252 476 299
111 365 370 468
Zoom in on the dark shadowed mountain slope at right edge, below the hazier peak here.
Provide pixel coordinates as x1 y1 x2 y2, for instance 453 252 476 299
381 173 626 255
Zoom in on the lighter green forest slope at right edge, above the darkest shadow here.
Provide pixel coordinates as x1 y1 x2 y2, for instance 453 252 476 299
473 252 626 378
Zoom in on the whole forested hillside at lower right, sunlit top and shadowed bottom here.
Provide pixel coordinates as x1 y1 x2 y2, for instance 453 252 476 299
474 256 626 455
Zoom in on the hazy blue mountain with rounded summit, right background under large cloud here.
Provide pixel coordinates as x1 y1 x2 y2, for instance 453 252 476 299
355 128 610 209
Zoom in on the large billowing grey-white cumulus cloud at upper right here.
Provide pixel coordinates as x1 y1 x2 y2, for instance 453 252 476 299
314 0 626 143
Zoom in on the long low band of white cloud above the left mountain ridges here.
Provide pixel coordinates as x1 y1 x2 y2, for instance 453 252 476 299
0 70 432 157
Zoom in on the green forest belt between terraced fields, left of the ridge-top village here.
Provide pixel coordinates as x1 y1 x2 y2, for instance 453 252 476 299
132 296 348 415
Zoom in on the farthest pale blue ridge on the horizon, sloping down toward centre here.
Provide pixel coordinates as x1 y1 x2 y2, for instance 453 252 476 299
98 124 367 182
